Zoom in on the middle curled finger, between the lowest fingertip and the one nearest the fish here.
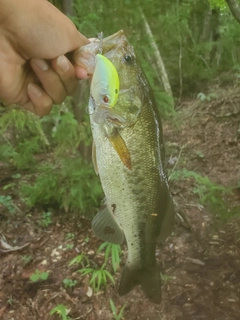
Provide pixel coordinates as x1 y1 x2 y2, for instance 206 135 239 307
30 59 67 104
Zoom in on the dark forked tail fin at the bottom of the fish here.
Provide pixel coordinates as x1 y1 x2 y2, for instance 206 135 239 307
118 265 161 303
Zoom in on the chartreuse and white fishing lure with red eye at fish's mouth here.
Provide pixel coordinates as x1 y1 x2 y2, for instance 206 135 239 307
90 54 119 108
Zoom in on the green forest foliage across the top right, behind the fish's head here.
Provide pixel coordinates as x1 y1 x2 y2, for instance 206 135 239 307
72 0 240 95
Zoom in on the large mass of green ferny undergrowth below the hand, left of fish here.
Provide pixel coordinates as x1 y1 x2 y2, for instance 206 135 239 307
0 98 102 213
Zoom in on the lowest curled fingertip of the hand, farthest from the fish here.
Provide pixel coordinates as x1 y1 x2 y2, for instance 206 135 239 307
22 83 53 116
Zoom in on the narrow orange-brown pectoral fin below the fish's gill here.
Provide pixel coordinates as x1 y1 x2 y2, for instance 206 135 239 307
108 129 132 170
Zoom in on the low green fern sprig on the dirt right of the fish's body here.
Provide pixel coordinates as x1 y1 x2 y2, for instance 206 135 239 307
169 169 232 218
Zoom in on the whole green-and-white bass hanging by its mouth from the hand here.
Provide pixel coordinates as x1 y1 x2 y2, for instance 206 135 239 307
77 30 175 303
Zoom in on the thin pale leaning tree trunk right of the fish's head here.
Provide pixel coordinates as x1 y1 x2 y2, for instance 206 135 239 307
140 8 172 97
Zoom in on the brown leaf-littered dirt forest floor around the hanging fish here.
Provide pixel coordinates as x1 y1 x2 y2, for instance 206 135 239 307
0 89 240 320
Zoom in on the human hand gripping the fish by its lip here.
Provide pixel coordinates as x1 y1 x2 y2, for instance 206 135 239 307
0 0 89 116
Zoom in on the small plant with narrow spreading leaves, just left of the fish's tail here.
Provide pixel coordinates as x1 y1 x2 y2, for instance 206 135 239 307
78 264 115 292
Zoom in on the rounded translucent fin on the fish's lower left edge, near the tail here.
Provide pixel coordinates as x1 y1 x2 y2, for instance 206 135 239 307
92 201 124 244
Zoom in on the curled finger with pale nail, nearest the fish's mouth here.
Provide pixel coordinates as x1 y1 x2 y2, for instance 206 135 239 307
51 55 78 95
